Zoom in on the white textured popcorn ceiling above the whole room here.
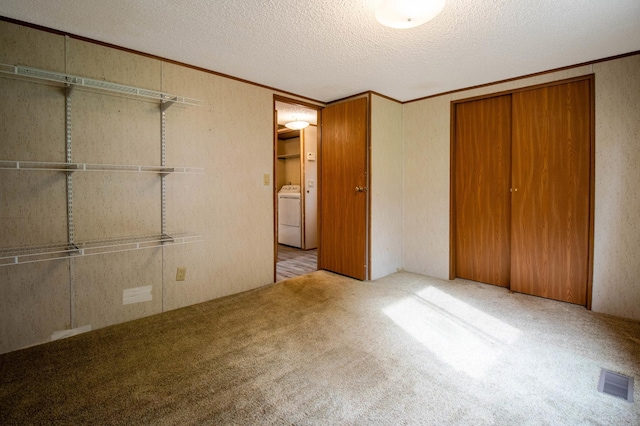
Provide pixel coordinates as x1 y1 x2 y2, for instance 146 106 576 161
0 0 640 102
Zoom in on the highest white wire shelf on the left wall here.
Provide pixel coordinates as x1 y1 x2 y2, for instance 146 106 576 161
0 64 203 106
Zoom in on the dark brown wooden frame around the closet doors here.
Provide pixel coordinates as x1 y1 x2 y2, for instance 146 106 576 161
449 74 596 310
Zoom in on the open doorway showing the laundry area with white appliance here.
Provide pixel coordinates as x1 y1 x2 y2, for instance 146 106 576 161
274 96 320 282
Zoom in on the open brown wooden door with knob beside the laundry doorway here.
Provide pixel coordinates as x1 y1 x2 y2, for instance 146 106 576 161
318 98 368 280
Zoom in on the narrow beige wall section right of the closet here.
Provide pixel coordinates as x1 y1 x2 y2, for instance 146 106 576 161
593 55 640 320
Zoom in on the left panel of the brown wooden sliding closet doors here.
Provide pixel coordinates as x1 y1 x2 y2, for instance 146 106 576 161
454 95 511 287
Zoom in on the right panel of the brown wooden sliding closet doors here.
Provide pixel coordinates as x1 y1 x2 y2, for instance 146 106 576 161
511 80 591 305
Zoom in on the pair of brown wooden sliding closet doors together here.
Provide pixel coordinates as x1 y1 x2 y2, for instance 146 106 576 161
454 79 592 305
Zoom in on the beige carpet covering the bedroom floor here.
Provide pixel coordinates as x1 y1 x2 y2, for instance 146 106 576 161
0 271 640 425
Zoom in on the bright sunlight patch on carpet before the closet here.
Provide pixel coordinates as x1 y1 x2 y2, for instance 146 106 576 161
383 287 520 379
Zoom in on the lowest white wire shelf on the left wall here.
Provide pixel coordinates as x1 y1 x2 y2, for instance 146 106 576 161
0 233 204 266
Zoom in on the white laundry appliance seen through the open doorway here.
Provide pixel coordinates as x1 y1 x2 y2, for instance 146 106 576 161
278 185 302 248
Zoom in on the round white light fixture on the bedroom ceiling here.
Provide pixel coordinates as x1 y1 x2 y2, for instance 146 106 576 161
376 0 445 29
